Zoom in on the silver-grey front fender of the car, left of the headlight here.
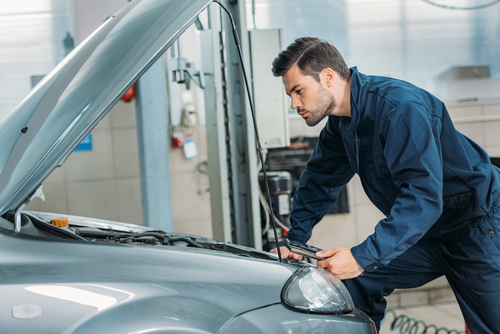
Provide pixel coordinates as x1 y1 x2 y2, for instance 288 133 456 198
0 223 297 333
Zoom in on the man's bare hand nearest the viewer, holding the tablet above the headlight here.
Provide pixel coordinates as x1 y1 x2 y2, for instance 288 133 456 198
316 247 363 279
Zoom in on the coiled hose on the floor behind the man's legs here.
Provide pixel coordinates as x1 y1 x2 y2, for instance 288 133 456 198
384 309 465 334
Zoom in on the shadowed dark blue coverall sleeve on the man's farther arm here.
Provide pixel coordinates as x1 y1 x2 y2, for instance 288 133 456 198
287 118 354 243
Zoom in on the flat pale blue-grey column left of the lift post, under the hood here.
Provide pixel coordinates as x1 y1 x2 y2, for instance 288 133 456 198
136 57 174 232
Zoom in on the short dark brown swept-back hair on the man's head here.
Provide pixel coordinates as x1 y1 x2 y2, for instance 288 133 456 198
272 37 351 82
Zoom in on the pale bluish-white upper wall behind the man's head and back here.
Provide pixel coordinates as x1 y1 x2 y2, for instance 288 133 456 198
246 0 500 104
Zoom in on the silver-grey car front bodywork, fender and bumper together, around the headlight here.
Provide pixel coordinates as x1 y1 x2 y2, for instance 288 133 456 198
0 212 374 334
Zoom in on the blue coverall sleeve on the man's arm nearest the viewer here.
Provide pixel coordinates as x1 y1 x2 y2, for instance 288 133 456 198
351 102 443 271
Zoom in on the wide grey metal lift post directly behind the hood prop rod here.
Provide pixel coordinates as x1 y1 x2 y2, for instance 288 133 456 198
202 1 262 249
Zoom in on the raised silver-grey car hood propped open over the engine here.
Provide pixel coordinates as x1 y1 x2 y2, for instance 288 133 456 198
0 0 211 215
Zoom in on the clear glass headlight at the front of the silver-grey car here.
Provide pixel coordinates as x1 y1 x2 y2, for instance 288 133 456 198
281 267 354 314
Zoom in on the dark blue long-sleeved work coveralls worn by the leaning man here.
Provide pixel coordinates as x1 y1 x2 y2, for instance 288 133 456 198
288 67 500 333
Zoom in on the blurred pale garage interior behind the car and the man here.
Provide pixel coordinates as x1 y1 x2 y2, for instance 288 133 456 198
0 0 500 333
